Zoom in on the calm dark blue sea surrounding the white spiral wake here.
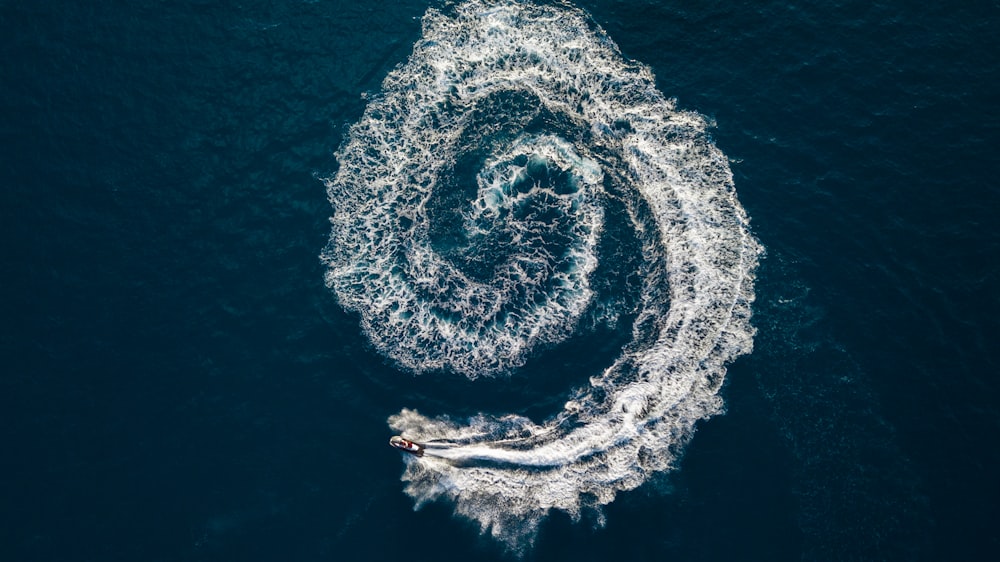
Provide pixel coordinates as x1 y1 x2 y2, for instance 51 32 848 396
0 1 1000 560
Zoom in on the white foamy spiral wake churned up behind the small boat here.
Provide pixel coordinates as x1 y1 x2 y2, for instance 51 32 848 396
323 0 761 550
